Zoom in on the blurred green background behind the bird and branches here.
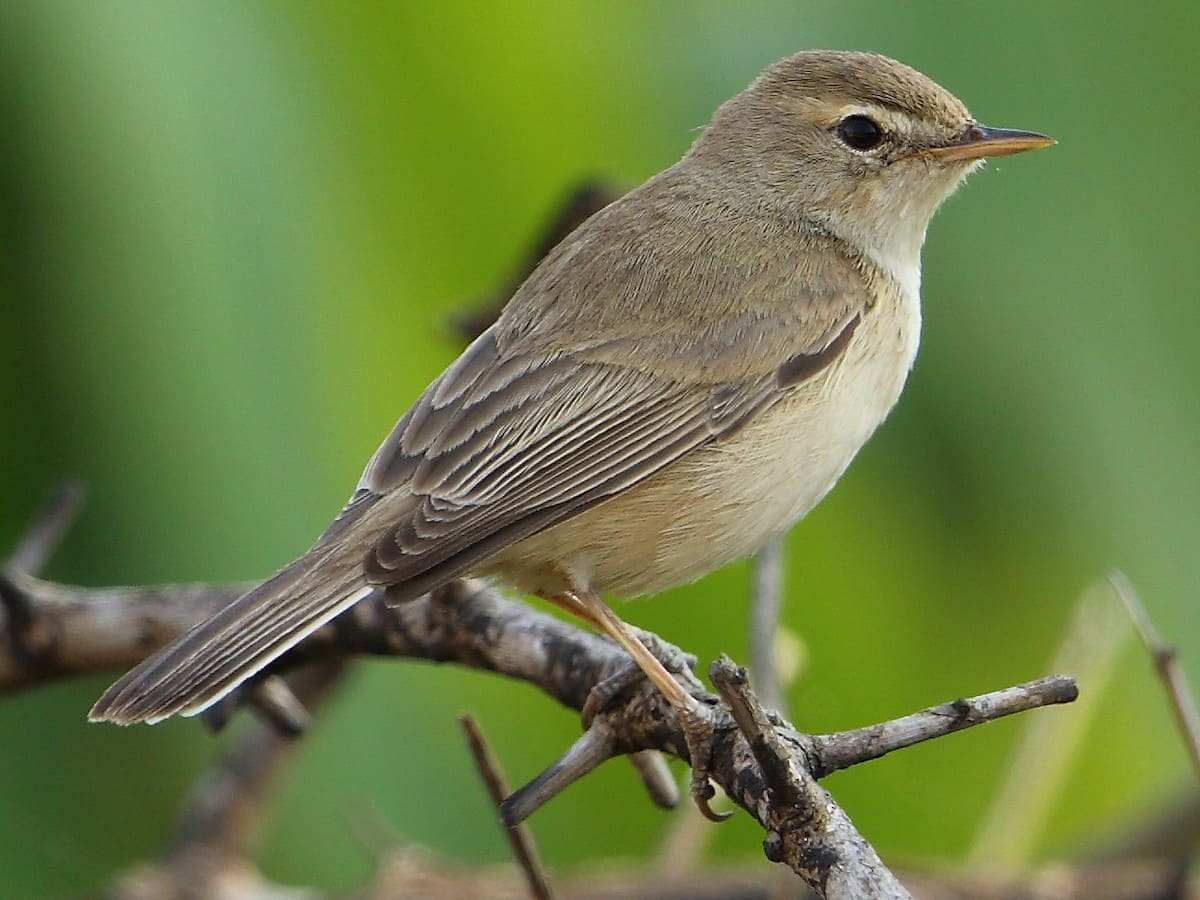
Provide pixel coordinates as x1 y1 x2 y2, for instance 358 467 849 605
0 0 1200 896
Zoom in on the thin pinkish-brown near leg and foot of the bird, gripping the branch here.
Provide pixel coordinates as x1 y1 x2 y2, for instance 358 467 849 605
552 589 728 822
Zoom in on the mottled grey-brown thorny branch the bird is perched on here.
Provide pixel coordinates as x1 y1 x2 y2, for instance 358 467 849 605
0 487 1089 896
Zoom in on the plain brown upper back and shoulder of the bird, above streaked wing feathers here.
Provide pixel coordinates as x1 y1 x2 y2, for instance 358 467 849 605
493 167 874 383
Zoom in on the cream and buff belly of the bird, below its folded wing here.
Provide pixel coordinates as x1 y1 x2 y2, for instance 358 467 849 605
472 314 916 596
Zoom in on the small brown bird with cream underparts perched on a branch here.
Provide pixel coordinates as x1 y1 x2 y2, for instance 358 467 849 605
91 52 1054 816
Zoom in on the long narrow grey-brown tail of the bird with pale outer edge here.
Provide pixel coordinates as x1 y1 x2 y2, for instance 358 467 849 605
88 540 374 725
